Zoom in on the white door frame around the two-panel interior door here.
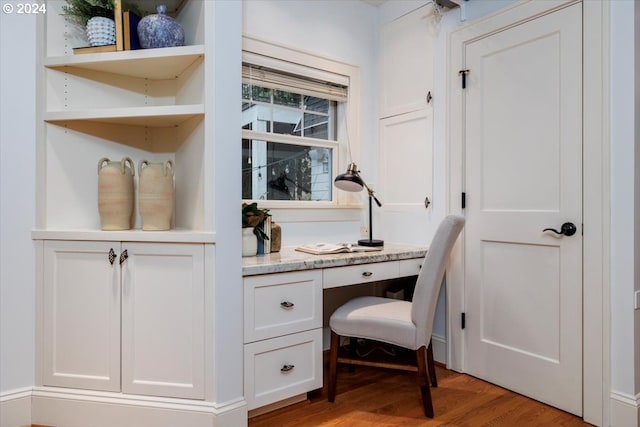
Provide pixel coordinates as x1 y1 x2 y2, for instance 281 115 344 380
446 0 610 426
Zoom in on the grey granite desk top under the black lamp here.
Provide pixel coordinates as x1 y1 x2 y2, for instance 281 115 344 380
242 243 427 276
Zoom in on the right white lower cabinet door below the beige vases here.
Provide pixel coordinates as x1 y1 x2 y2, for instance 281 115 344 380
122 243 205 399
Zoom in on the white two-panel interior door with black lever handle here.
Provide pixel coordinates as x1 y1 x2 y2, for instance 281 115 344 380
464 4 582 415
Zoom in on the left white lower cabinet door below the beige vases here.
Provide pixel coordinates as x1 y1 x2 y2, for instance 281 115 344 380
42 241 120 391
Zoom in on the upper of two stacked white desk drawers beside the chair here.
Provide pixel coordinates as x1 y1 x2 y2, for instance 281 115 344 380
244 270 322 343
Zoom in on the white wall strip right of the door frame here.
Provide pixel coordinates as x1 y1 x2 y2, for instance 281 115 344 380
610 1 640 416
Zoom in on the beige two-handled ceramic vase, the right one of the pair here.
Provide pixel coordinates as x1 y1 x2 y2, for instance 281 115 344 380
138 160 174 231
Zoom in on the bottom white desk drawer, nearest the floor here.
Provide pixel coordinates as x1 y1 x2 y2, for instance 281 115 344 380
244 328 322 410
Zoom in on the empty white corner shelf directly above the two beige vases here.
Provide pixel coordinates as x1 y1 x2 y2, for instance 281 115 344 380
44 104 204 127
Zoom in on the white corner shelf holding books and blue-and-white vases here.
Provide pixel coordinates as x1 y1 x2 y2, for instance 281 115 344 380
44 45 204 80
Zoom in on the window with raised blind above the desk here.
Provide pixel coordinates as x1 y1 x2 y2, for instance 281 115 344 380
242 64 347 202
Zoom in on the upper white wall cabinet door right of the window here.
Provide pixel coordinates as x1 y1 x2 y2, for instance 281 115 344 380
380 4 436 117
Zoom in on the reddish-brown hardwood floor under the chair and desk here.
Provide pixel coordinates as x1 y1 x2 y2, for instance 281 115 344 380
249 365 591 427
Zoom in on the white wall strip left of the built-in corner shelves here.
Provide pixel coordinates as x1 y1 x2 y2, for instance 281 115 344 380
0 2 36 396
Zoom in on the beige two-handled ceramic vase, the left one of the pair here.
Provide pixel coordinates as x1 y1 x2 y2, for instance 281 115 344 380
98 157 135 230
